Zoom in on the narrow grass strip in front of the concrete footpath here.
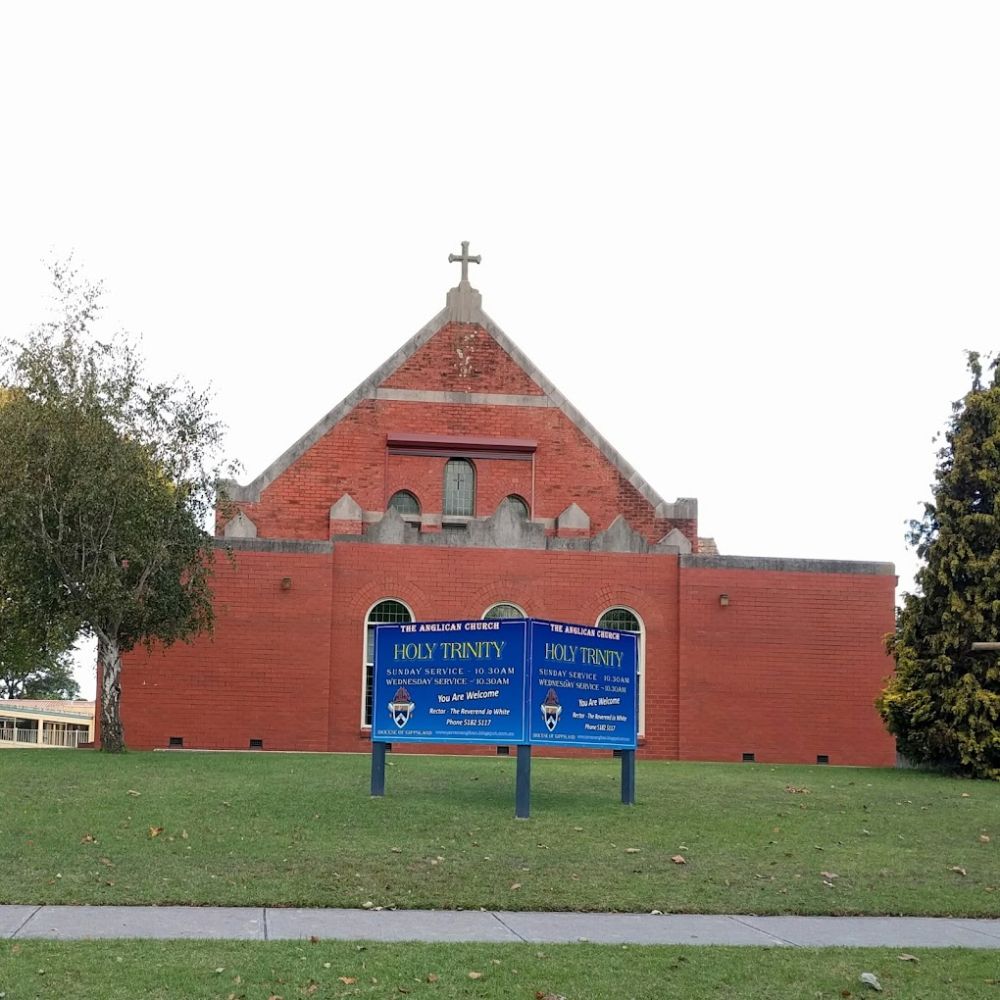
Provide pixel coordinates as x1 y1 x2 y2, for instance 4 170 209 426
0 941 1000 1000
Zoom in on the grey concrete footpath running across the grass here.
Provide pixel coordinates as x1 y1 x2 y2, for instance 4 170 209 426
0 906 1000 950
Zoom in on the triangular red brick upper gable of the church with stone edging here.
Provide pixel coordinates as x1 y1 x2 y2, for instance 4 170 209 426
220 248 697 545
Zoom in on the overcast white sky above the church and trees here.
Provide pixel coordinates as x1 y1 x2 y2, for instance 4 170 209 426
0 0 1000 690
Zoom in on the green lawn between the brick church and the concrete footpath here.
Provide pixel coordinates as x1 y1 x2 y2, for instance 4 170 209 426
0 750 1000 916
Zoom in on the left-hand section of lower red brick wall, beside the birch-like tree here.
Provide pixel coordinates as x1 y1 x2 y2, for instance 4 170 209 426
122 552 330 750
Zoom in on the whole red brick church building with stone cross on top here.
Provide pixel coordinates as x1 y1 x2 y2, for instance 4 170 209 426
122 244 895 765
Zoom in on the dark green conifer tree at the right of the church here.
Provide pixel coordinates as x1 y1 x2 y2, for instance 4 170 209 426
878 352 1000 780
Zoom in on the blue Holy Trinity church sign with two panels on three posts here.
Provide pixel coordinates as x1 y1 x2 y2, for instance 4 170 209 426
371 618 639 818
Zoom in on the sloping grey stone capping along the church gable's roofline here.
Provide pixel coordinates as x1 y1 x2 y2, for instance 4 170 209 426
226 289 698 521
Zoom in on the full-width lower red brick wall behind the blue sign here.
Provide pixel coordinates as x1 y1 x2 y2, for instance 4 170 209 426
113 542 894 765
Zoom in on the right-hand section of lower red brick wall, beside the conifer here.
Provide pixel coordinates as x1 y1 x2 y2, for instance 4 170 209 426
679 567 895 765
